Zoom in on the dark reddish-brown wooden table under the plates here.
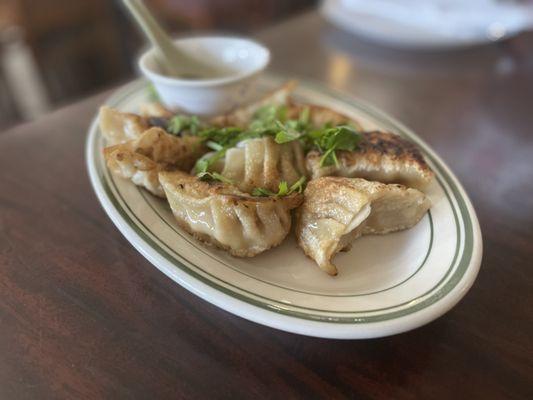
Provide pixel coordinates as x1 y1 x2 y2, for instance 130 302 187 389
0 13 533 399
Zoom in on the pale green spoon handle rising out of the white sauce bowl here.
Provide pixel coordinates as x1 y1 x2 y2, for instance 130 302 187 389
123 0 180 74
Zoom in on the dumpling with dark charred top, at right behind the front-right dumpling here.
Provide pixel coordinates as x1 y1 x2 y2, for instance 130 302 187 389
306 131 433 190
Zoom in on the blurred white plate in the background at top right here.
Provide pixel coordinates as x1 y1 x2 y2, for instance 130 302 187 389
321 0 533 50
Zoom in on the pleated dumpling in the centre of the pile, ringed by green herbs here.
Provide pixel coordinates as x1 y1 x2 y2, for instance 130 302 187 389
209 136 307 193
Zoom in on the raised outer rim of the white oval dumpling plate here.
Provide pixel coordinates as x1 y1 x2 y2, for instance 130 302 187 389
86 77 482 338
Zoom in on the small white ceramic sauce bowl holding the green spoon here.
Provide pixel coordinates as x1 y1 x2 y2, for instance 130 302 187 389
139 36 270 115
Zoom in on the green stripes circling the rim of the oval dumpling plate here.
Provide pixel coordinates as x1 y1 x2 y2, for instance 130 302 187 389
94 78 473 324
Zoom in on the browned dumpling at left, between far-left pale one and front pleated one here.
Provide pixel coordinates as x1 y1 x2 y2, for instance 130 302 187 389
104 128 206 197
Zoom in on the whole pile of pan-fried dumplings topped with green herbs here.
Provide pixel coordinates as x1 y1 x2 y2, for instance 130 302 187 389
99 81 434 276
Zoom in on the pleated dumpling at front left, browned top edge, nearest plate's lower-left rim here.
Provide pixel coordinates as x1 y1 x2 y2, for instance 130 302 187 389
159 171 302 257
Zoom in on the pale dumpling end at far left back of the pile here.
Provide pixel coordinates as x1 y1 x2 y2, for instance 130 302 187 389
98 106 149 146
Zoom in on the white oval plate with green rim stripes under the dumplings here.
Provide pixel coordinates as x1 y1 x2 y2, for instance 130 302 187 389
86 77 482 339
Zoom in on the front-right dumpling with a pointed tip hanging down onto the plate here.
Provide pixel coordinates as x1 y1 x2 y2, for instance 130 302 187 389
295 177 430 275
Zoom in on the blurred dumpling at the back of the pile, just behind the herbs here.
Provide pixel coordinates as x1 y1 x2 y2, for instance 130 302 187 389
211 81 296 128
